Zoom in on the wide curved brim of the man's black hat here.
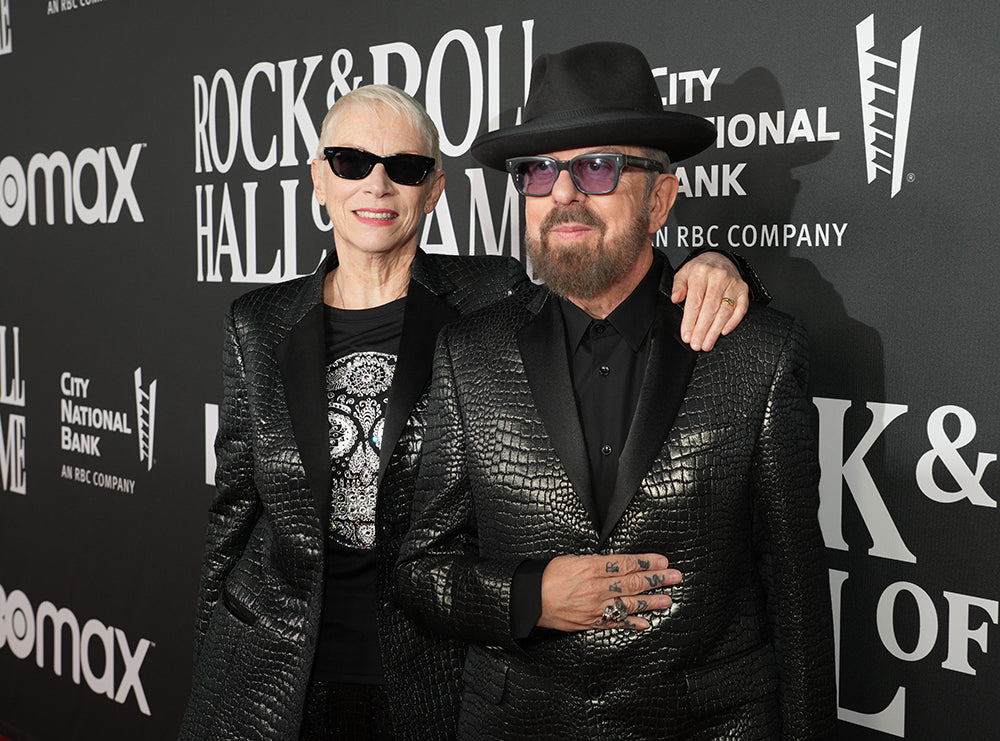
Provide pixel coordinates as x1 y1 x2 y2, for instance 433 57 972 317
470 108 716 170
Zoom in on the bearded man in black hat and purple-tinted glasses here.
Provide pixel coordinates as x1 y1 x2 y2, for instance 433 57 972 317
397 43 835 741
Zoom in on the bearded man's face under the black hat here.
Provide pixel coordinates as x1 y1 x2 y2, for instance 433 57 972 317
524 146 676 300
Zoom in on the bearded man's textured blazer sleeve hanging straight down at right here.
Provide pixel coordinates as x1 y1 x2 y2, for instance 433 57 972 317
752 321 836 739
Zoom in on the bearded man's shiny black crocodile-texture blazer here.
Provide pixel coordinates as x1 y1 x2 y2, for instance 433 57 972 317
397 258 836 741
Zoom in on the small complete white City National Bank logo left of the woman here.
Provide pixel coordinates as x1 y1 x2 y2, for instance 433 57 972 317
59 368 156 494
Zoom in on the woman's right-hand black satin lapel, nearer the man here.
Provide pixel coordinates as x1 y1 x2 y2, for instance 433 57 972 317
378 280 458 483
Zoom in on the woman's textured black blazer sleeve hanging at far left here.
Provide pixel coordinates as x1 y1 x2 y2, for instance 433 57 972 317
195 309 260 661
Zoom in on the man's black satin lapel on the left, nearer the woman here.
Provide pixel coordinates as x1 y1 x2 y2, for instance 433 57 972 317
517 296 597 523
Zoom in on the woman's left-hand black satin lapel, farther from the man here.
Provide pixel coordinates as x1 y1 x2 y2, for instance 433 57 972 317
276 304 331 522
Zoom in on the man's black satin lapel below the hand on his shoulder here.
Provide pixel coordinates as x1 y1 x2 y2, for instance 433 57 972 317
598 294 698 547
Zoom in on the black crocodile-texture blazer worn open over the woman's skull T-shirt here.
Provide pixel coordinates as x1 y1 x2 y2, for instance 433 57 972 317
180 252 527 741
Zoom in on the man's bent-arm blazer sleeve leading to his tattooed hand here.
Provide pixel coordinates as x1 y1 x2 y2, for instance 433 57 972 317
396 328 520 650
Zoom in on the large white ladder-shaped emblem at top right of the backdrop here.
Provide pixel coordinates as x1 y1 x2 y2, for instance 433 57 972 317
856 15 922 198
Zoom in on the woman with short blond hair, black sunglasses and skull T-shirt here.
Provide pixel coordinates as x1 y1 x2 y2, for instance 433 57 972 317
181 85 747 741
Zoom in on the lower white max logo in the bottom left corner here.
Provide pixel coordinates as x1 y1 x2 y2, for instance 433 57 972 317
0 585 155 715
